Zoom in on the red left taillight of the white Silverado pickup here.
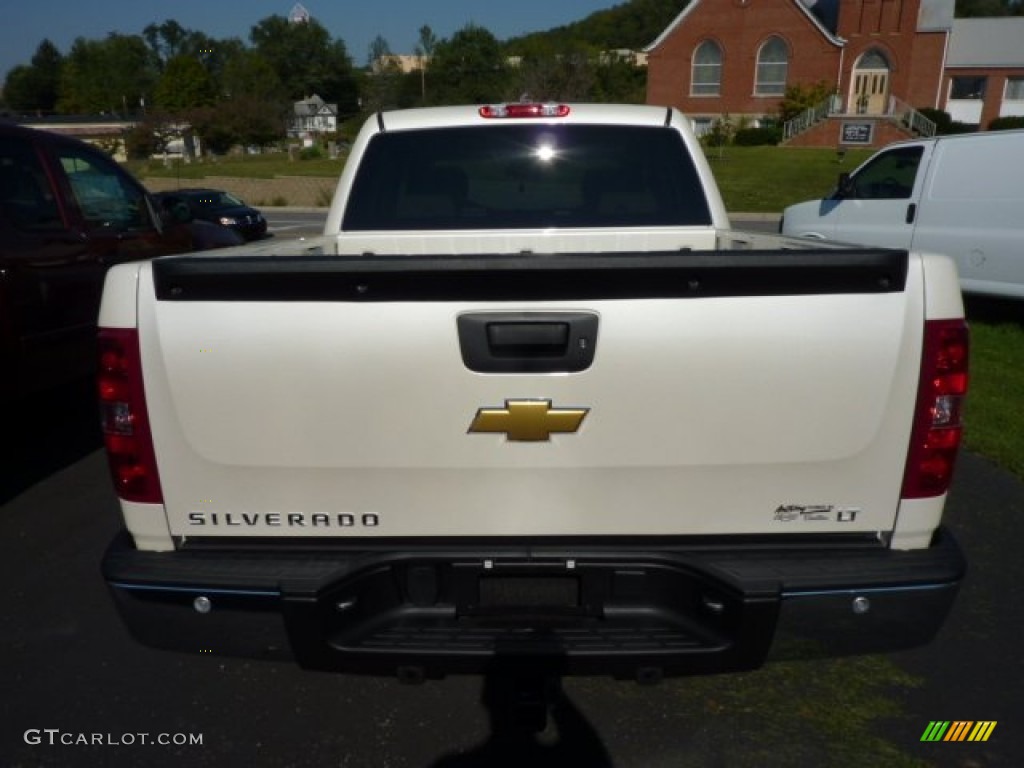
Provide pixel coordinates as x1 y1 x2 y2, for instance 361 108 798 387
97 328 164 504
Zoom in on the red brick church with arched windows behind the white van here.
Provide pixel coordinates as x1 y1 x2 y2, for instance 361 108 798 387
646 0 1024 146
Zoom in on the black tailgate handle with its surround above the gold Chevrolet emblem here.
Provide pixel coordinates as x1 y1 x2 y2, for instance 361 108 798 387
458 312 598 374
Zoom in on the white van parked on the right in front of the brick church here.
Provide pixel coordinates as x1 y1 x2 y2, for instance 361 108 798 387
781 130 1024 298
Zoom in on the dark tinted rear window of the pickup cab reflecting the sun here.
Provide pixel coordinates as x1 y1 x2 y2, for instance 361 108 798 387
342 123 711 231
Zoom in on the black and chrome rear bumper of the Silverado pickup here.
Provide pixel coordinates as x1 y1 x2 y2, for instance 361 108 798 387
103 531 966 680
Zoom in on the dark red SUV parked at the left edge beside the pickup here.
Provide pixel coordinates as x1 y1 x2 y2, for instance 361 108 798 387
0 123 242 394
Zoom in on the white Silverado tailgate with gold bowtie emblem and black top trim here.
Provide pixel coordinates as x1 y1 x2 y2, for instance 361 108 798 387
138 250 924 539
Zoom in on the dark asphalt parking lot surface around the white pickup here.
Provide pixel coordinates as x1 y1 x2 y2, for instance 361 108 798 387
0 219 1024 768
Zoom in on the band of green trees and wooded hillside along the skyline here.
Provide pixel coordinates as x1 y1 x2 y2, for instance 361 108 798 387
0 0 1024 155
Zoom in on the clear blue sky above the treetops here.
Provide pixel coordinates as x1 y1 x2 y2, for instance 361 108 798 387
0 0 626 81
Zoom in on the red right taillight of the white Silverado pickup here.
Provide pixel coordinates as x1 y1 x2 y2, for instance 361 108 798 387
903 319 968 499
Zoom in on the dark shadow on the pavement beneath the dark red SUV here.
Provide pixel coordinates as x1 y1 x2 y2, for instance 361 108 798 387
0 378 102 504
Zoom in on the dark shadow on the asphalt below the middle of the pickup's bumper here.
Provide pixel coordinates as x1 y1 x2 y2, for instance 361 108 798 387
433 673 612 768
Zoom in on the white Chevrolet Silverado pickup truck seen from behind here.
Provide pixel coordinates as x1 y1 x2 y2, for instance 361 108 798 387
99 104 968 681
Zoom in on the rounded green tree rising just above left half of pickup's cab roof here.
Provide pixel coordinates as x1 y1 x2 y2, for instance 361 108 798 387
429 24 512 104
